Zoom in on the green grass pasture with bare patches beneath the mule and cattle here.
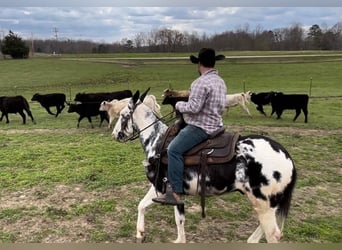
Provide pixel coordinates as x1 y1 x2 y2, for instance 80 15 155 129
0 52 342 243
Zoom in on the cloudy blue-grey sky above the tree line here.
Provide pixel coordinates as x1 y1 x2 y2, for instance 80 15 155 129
0 0 342 43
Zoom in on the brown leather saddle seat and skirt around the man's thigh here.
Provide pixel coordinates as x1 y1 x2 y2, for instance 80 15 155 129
161 128 240 166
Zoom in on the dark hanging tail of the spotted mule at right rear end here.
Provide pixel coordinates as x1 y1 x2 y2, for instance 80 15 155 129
277 167 297 231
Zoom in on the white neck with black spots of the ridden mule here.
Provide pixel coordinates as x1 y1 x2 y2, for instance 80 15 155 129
134 106 168 159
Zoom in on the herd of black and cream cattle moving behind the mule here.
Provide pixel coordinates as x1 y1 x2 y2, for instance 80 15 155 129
0 89 309 127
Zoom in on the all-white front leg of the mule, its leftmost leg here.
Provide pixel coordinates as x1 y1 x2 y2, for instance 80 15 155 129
136 185 157 242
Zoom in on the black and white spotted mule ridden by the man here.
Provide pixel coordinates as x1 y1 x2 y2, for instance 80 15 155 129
112 91 296 243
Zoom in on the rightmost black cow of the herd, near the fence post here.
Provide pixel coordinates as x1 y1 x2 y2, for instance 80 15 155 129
271 93 309 123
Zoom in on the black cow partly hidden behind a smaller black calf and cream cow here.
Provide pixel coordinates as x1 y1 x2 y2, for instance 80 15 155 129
75 90 132 103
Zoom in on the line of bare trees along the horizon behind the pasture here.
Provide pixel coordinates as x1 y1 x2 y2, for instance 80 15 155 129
0 22 342 57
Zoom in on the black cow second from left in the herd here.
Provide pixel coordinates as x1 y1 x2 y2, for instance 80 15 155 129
31 93 66 117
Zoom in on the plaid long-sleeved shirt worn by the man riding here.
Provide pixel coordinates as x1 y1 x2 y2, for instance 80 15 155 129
176 69 227 135
